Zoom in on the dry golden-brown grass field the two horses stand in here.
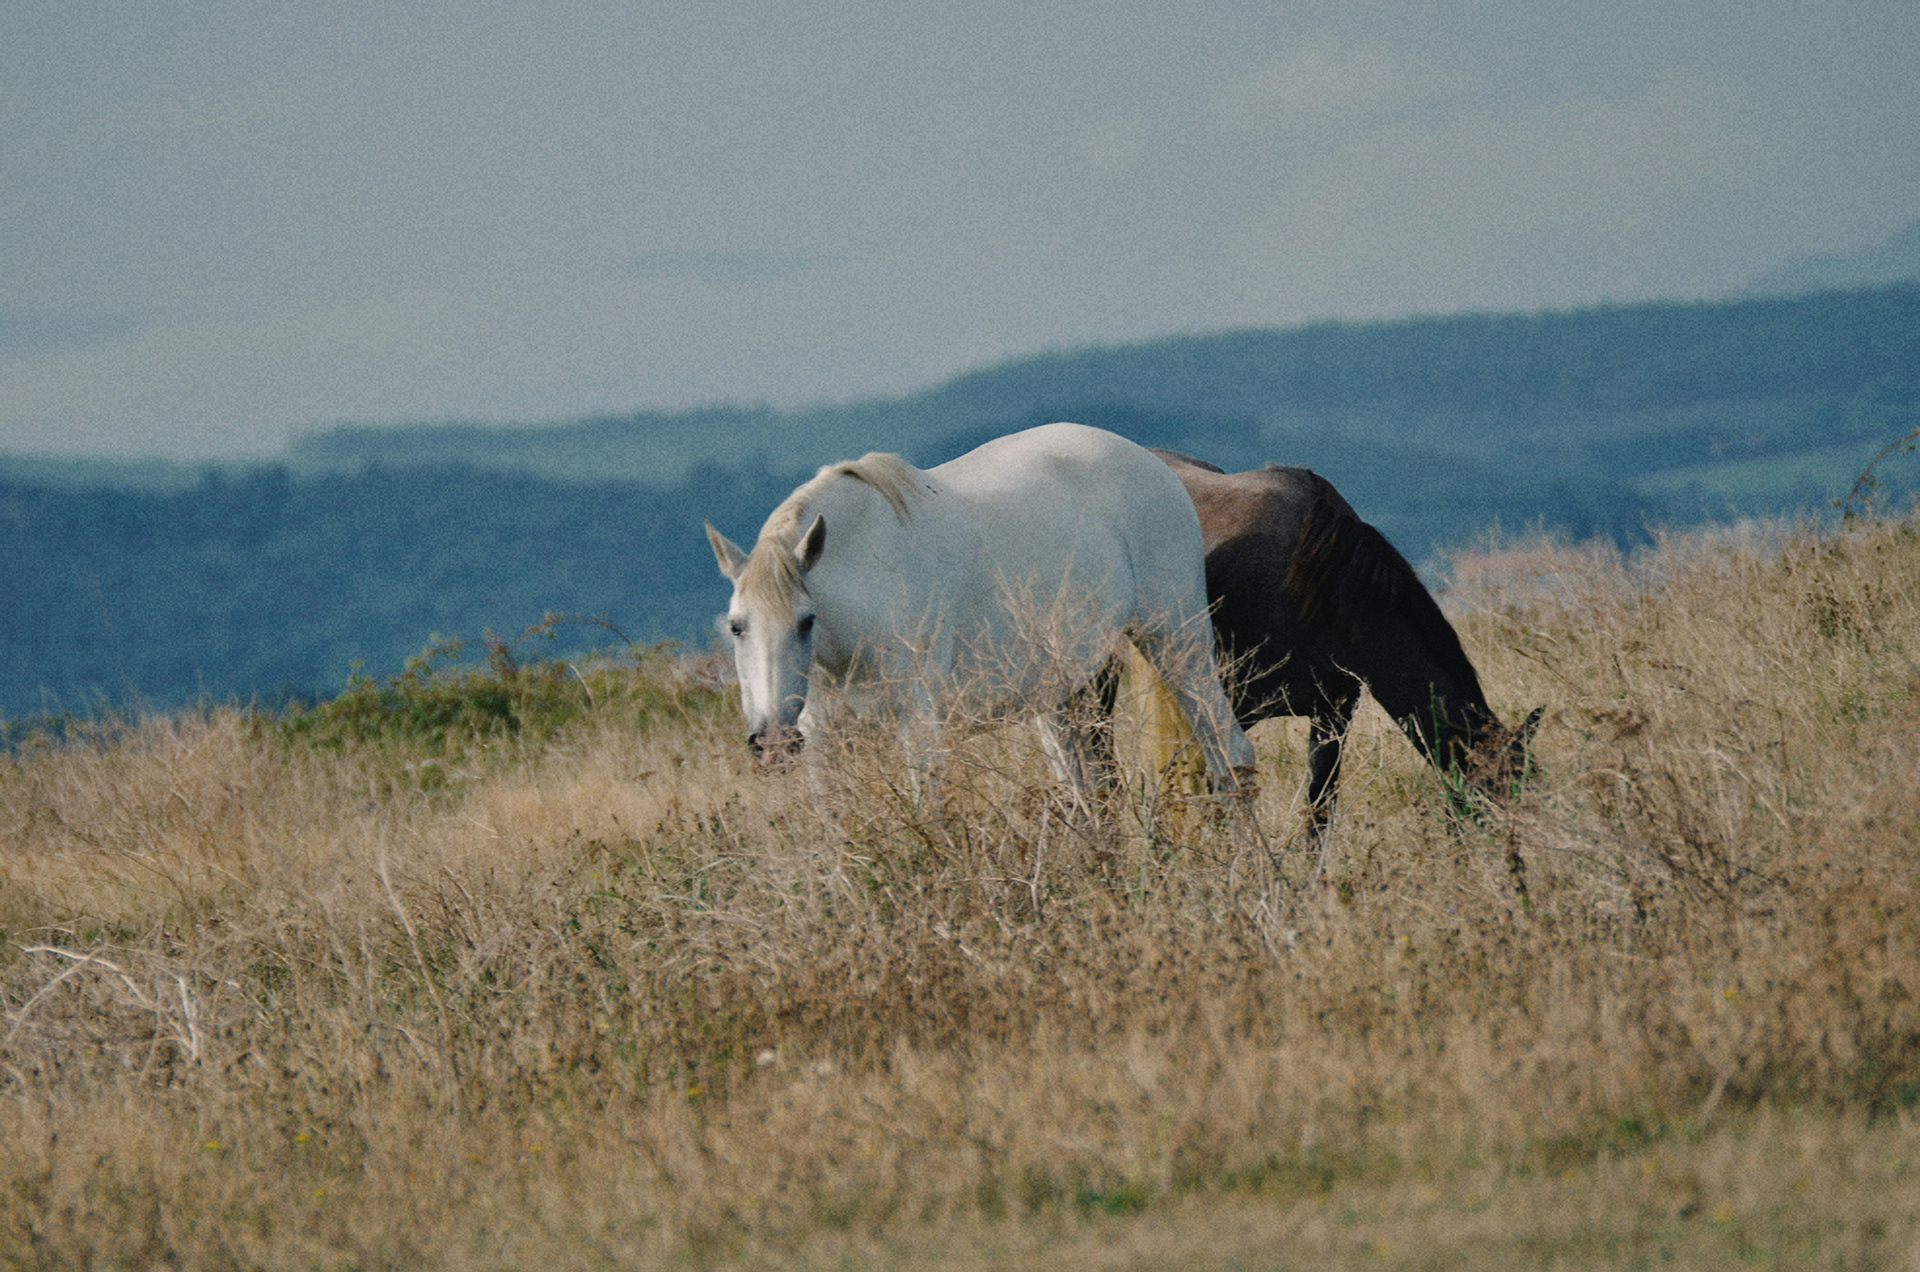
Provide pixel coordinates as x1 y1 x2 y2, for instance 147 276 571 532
0 519 1920 1272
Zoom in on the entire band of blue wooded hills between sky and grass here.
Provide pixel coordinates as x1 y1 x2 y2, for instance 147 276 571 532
0 284 1920 717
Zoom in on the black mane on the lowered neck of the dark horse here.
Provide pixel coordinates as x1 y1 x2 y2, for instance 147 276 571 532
1281 471 1480 707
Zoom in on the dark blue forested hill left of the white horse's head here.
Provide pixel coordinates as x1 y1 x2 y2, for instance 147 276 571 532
0 467 799 719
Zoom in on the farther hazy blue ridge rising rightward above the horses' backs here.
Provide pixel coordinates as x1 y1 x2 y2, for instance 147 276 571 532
292 282 1920 555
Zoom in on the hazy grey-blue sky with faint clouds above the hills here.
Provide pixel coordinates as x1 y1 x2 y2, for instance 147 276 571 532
0 0 1920 457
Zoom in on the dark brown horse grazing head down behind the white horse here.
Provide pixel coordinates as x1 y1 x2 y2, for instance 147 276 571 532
1154 450 1540 832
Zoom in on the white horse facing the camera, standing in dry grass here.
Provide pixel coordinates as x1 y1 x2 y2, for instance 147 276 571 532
707 425 1254 792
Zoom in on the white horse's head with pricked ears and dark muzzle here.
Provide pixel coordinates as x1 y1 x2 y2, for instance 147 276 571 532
707 517 828 761
